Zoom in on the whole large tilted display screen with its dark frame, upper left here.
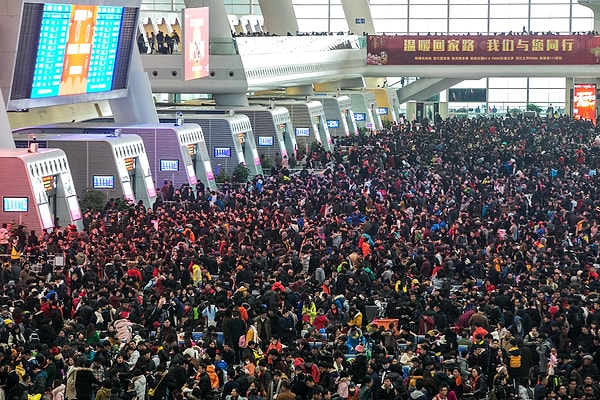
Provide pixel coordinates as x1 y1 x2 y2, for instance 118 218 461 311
8 2 138 109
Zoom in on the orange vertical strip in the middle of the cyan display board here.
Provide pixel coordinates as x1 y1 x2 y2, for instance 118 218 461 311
58 5 98 95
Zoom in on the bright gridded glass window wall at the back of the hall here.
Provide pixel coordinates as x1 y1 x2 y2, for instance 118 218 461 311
142 0 594 112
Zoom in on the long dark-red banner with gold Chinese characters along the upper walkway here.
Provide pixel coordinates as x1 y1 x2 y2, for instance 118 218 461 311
367 35 600 65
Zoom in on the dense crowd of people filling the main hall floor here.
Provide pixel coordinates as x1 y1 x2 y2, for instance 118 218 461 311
0 116 600 400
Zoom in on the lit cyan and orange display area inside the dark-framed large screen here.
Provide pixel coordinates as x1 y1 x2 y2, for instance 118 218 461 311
31 4 123 98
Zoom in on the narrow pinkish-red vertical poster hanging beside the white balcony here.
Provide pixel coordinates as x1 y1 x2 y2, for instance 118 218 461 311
183 7 209 81
